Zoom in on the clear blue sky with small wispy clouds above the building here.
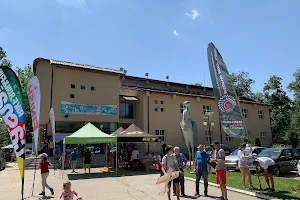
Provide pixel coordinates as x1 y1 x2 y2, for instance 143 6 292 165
0 0 300 96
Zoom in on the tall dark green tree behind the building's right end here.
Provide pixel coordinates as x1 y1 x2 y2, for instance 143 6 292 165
263 76 292 140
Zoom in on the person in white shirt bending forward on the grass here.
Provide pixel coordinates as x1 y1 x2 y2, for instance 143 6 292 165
253 157 275 192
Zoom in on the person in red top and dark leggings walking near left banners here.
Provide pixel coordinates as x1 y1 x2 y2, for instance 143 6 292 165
39 153 54 196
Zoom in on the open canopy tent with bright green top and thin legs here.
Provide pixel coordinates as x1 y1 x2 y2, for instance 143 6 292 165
62 123 118 173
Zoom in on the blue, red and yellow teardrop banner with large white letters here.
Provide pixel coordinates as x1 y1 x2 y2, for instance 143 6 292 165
0 66 26 199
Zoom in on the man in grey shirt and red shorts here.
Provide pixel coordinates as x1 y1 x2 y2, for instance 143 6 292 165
210 141 228 200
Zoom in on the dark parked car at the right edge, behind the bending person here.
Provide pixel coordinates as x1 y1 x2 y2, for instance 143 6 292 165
257 148 300 176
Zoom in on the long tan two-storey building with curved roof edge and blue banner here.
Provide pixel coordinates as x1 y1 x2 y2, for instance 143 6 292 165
33 58 272 152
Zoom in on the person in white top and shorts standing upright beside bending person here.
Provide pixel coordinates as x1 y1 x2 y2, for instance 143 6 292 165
238 143 254 190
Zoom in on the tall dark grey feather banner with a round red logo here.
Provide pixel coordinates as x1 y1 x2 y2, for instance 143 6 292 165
207 43 246 138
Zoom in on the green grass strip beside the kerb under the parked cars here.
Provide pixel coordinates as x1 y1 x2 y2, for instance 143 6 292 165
185 170 300 199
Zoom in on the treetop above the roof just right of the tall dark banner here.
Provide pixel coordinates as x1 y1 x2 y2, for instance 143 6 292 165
229 71 255 98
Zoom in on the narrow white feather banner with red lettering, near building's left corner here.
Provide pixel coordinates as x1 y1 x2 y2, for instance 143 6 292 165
27 76 41 154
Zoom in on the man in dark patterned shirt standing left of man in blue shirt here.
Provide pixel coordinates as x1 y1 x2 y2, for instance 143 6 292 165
173 147 187 197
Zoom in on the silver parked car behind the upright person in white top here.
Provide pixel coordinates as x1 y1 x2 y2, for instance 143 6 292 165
225 146 266 170
